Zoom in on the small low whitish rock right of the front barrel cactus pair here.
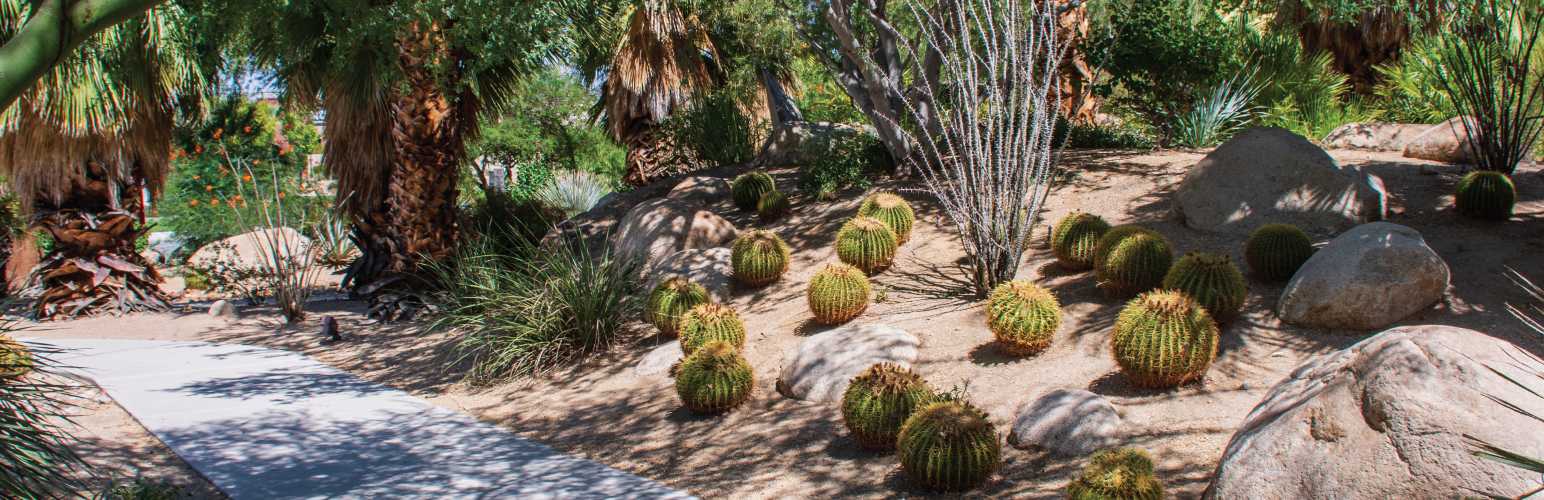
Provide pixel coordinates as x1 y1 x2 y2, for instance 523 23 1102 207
1008 389 1121 457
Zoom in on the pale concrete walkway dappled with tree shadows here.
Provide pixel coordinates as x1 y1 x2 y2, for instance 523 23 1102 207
40 340 689 498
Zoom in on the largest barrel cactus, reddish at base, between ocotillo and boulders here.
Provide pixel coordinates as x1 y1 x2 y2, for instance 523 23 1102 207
1110 290 1218 389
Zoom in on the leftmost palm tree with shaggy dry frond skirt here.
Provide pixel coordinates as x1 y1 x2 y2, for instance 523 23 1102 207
0 0 205 318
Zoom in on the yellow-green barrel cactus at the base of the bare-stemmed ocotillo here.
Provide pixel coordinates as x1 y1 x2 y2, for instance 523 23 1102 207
987 281 1061 356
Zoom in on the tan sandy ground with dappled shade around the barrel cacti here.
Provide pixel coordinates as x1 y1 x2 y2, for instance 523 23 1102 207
37 151 1544 498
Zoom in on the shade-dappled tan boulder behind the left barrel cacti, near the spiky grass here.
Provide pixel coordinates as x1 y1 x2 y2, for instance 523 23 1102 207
613 198 740 269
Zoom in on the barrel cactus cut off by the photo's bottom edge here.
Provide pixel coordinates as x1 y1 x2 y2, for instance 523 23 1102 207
1067 448 1163 500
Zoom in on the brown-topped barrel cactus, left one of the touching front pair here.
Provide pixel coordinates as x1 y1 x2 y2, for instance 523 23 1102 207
841 363 933 451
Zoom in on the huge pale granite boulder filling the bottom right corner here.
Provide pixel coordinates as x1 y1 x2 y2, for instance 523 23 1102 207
1206 326 1544 498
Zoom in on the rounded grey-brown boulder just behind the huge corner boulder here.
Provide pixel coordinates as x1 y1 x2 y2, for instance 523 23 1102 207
1277 222 1448 330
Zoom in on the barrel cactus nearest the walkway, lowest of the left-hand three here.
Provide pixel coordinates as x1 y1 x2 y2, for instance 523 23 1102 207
676 343 755 415
